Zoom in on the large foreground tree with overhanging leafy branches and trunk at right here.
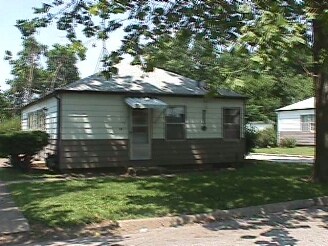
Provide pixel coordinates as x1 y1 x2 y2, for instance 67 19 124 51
22 0 328 182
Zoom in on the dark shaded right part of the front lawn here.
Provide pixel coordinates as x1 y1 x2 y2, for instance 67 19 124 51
122 164 328 214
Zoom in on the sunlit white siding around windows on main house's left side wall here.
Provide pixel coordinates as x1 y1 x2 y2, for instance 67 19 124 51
21 97 58 139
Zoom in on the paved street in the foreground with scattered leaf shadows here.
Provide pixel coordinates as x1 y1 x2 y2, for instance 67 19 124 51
24 207 328 246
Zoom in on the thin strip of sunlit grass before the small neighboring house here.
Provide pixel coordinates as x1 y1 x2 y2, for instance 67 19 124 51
254 146 314 156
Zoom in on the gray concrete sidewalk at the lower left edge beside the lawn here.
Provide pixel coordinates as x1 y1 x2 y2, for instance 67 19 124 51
0 181 30 235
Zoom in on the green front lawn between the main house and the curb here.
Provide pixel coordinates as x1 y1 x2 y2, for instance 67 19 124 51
9 163 328 227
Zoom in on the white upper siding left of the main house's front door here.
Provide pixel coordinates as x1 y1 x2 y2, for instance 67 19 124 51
62 94 129 139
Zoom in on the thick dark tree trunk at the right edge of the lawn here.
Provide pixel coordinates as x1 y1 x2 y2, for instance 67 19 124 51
313 5 328 183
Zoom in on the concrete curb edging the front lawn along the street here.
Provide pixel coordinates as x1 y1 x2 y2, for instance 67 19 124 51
118 196 328 232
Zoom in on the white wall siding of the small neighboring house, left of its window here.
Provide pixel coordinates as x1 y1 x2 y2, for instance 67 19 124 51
278 109 314 132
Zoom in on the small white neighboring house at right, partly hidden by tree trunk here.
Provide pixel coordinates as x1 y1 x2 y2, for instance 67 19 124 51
276 97 315 145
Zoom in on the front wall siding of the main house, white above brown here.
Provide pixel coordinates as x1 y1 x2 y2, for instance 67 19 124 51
60 93 244 169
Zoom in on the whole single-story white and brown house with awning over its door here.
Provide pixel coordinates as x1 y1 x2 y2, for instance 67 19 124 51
22 63 245 169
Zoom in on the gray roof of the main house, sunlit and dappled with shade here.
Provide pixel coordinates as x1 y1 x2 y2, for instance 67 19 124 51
60 61 244 98
